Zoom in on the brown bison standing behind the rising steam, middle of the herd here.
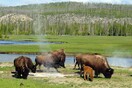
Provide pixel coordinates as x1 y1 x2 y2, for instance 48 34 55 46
35 49 66 70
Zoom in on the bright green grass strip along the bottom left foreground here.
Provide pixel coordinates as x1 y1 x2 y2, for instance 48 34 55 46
0 78 70 88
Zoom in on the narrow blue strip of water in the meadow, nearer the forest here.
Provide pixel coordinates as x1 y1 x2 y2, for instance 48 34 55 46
0 40 62 45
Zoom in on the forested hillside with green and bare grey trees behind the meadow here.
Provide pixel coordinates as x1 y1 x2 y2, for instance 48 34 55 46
0 2 132 38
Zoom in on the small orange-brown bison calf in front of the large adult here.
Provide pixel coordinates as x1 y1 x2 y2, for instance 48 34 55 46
83 64 94 81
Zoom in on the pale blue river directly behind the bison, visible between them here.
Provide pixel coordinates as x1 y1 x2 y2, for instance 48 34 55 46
0 54 132 67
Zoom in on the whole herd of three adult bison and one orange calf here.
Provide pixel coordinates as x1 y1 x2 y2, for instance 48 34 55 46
14 49 114 81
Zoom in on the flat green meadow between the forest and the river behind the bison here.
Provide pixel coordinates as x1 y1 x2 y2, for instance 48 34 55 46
0 35 132 57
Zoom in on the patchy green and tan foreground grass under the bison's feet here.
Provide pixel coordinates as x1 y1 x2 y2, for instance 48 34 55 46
0 65 132 88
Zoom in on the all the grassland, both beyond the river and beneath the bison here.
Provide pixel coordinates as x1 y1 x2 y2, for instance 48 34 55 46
0 35 132 88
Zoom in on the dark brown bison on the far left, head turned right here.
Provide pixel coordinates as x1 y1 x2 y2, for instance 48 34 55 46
14 56 36 79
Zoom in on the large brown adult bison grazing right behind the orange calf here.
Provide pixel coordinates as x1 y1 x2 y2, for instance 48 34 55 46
78 54 114 78
